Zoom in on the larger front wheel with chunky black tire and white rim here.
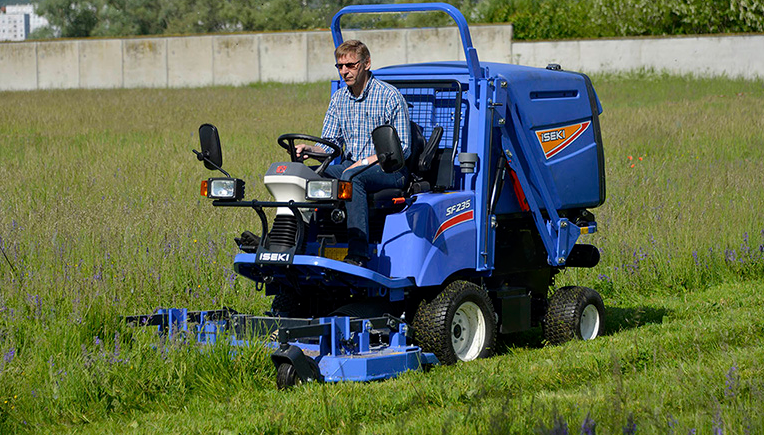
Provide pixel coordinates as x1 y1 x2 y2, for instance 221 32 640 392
411 281 496 364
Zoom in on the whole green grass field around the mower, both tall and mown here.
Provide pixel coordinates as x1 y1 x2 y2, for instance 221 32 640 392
0 73 764 434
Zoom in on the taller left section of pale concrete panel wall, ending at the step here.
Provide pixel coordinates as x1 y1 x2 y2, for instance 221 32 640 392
0 25 512 91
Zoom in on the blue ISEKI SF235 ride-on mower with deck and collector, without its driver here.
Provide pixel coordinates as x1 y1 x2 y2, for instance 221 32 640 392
128 3 605 387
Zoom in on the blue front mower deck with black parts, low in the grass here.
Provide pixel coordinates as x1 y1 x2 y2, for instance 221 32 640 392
125 308 438 388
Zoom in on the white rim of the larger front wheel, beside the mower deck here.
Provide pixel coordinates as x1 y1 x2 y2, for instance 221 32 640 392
451 302 486 361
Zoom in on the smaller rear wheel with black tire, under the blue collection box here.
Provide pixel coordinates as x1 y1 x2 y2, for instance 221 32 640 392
543 286 605 344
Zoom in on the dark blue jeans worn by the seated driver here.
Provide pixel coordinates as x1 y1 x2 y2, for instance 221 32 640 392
324 160 408 259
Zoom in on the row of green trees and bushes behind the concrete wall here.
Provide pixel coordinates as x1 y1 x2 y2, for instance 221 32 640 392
28 0 764 40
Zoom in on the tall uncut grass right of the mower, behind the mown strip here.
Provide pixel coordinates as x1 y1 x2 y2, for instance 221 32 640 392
561 73 764 297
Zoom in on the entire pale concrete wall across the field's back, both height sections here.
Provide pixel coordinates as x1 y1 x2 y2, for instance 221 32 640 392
0 25 764 91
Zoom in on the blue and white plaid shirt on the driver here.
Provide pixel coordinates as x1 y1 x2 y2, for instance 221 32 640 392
321 75 411 161
